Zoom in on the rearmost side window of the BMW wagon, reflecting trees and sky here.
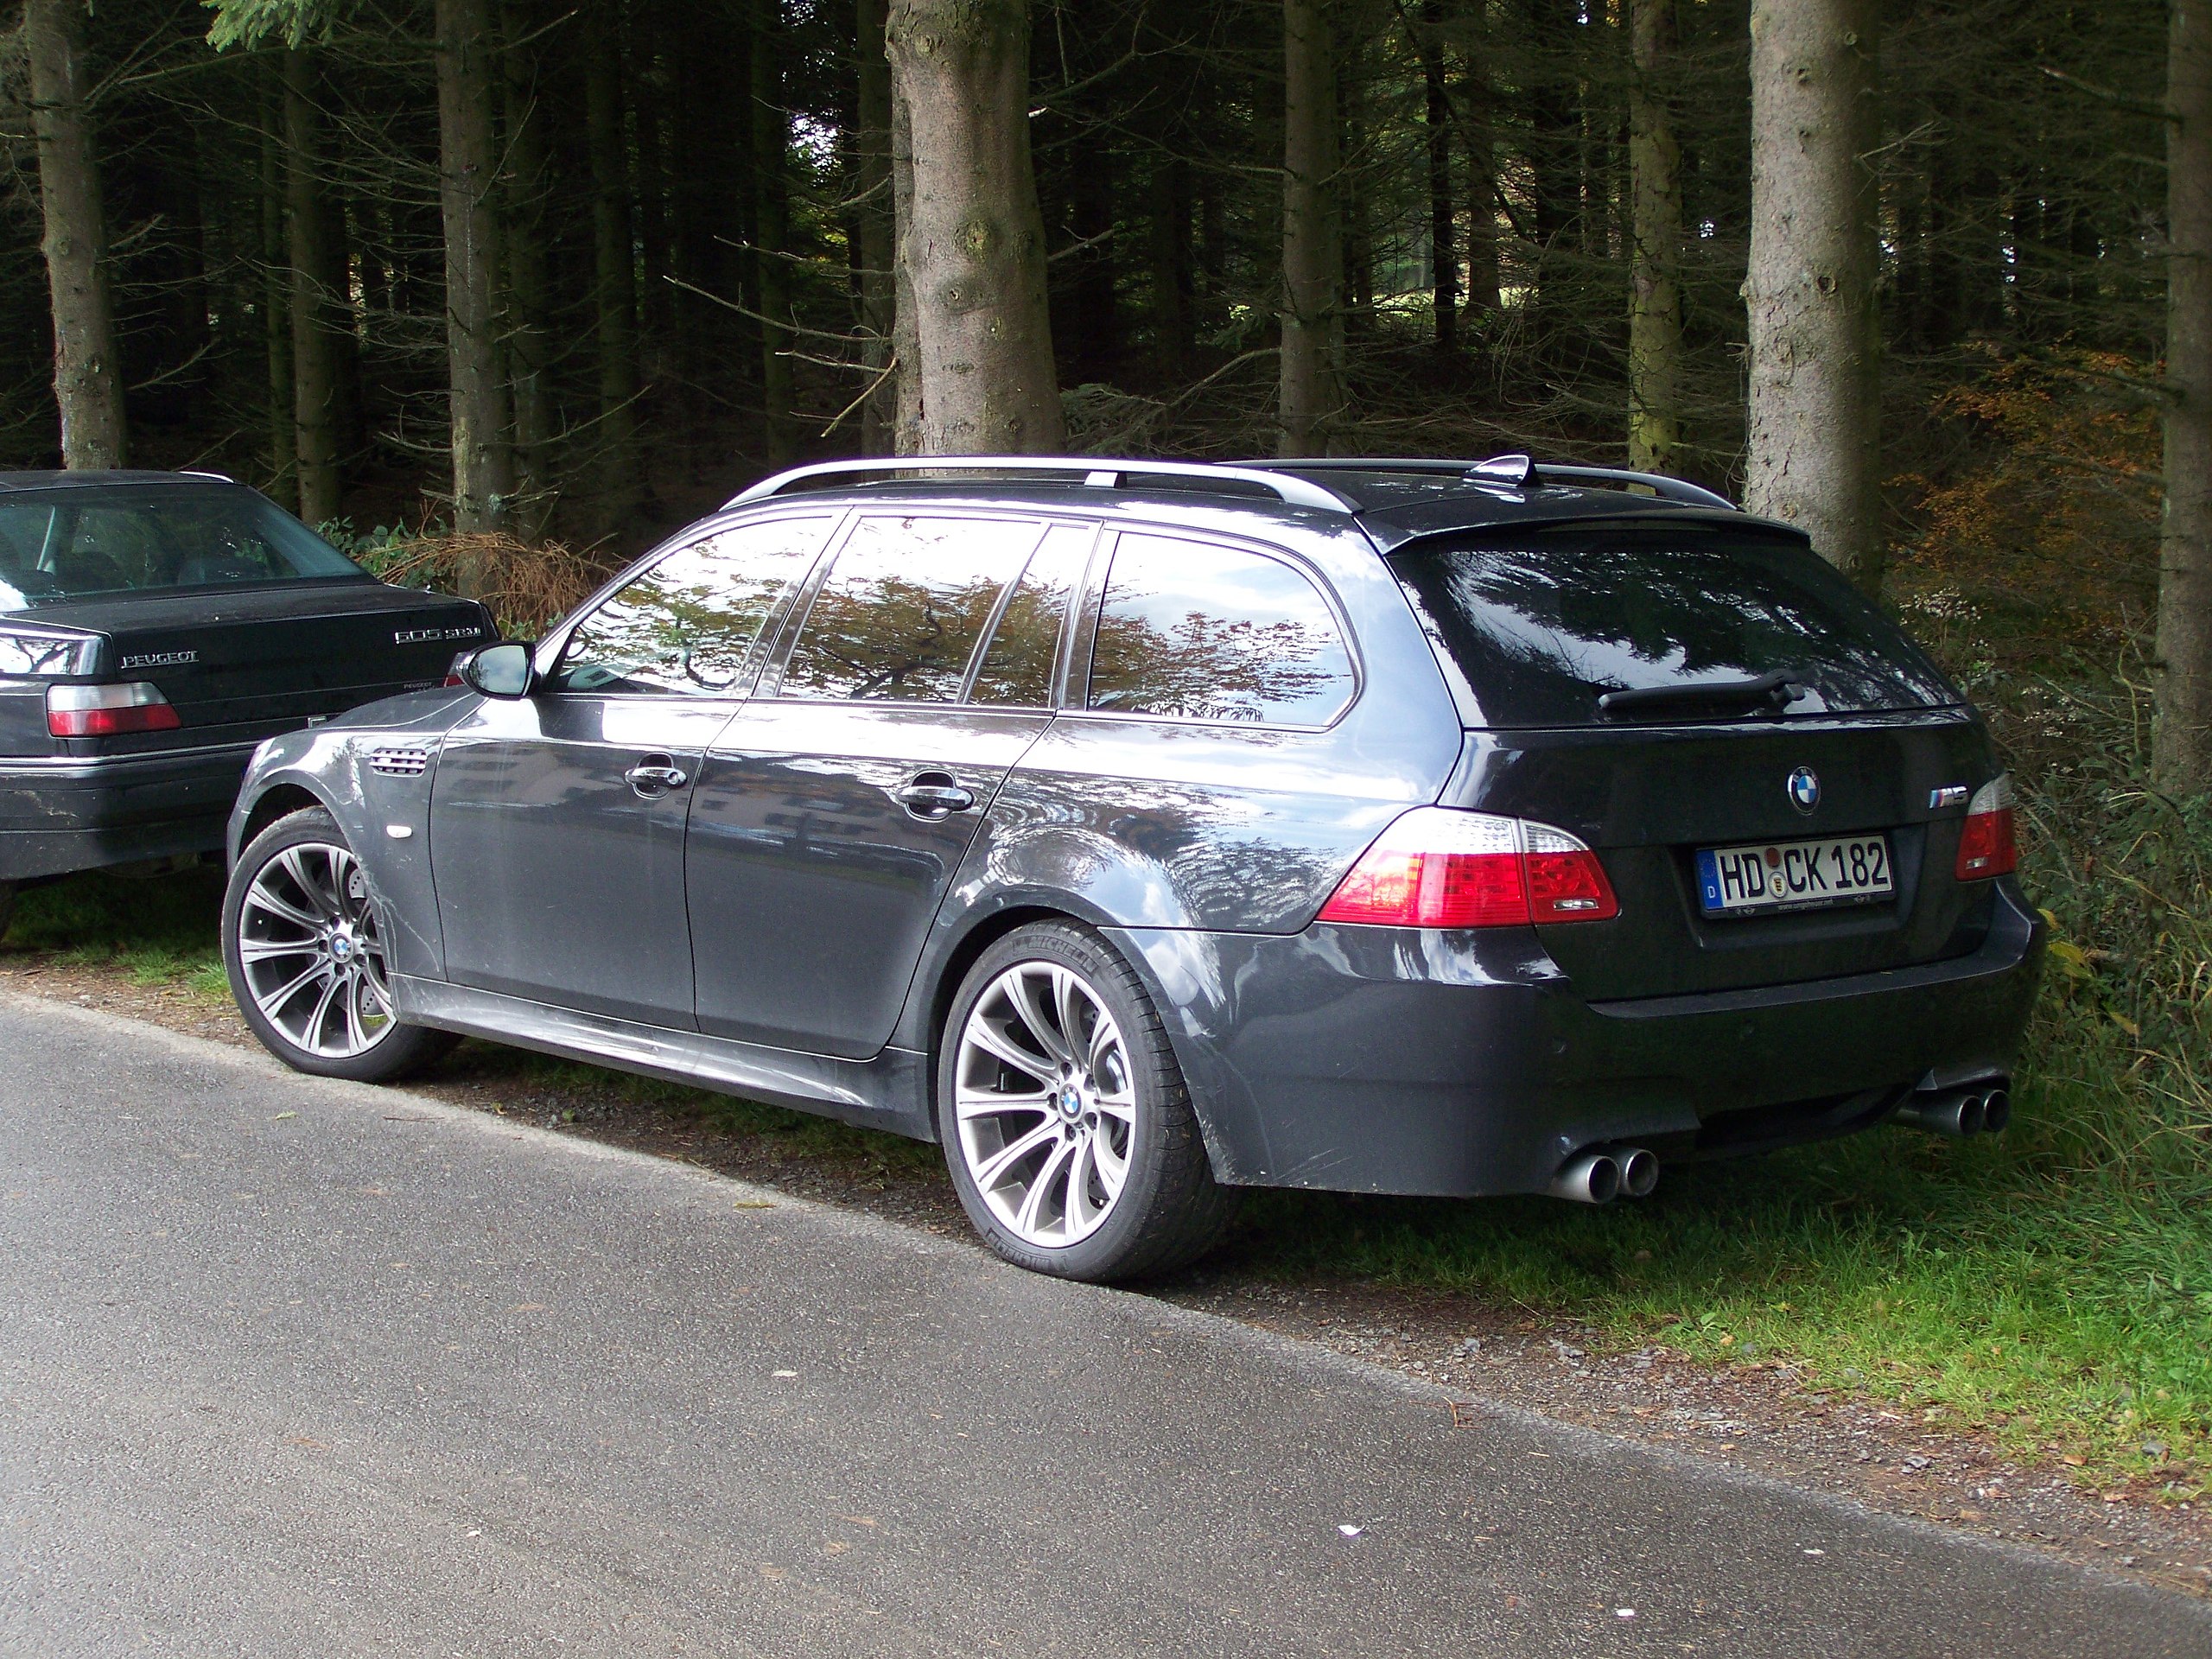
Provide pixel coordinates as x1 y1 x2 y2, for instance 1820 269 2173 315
1090 536 1354 726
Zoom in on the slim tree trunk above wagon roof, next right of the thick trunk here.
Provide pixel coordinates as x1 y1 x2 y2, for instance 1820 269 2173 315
1276 0 1343 455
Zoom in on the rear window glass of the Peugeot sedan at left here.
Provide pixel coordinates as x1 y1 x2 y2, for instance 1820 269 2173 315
0 485 365 611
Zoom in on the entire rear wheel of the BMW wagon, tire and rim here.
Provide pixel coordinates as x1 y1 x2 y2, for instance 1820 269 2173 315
938 923 1232 1279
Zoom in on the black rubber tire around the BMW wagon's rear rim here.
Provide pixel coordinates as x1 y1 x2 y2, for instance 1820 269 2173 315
936 923 1236 1283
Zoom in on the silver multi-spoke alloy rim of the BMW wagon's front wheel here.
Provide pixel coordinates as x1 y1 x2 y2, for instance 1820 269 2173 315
238 841 396 1059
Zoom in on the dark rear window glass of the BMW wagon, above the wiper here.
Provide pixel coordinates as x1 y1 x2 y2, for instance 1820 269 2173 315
1389 524 1960 726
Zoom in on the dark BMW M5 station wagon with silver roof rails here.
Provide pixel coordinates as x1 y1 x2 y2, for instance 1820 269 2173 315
224 455 2039 1279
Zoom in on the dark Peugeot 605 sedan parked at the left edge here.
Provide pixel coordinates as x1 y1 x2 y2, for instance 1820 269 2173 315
0 474 495 931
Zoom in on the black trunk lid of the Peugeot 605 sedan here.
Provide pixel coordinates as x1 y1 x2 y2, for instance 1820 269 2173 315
35 577 491 754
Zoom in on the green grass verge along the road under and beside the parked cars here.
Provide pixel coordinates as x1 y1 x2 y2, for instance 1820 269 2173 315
7 677 2212 1496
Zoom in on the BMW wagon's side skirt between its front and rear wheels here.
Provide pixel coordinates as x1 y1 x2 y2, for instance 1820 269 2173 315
391 973 938 1141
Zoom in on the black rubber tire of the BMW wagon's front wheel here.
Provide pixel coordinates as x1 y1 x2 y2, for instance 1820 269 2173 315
224 807 460 1084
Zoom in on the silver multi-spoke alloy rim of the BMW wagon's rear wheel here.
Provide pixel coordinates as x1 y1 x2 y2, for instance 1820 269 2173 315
953 963 1137 1248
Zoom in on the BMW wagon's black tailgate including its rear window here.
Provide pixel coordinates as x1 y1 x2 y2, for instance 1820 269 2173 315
1391 515 1993 1000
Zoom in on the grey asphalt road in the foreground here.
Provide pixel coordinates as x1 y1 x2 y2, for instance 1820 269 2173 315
0 995 2212 1659
